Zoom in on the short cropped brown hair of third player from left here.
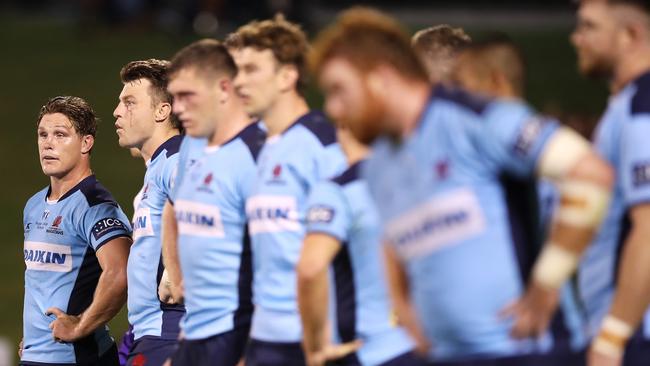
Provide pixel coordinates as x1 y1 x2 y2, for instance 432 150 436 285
167 39 237 78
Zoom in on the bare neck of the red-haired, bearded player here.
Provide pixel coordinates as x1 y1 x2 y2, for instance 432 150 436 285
389 80 431 137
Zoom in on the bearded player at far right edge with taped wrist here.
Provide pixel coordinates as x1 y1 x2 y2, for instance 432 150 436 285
571 0 650 366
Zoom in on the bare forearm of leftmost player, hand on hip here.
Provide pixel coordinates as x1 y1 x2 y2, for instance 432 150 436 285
78 267 126 336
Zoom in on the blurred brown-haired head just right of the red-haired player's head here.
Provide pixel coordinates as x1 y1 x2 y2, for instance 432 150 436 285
411 24 472 83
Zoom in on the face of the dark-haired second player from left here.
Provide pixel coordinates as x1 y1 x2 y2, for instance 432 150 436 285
113 79 156 149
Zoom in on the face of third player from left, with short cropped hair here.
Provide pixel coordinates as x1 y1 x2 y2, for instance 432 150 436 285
167 68 220 137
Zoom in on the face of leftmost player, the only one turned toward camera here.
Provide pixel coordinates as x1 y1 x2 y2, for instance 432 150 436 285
37 113 93 178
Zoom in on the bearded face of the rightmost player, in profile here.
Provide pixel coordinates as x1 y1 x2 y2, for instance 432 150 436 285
571 1 618 78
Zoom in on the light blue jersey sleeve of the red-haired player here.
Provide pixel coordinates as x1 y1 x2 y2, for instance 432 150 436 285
470 101 559 177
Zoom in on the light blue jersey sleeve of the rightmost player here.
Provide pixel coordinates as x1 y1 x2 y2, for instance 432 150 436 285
618 114 650 207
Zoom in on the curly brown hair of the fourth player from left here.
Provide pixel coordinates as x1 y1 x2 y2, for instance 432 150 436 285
225 15 309 94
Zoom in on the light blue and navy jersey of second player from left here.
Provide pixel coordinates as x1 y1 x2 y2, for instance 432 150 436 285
127 136 184 340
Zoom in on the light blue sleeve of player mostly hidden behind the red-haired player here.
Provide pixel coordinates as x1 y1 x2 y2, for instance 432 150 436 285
307 181 352 243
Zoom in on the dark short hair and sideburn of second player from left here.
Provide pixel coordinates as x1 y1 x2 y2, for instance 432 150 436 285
120 58 182 130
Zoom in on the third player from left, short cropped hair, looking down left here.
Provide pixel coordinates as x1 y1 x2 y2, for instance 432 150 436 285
162 39 265 366
